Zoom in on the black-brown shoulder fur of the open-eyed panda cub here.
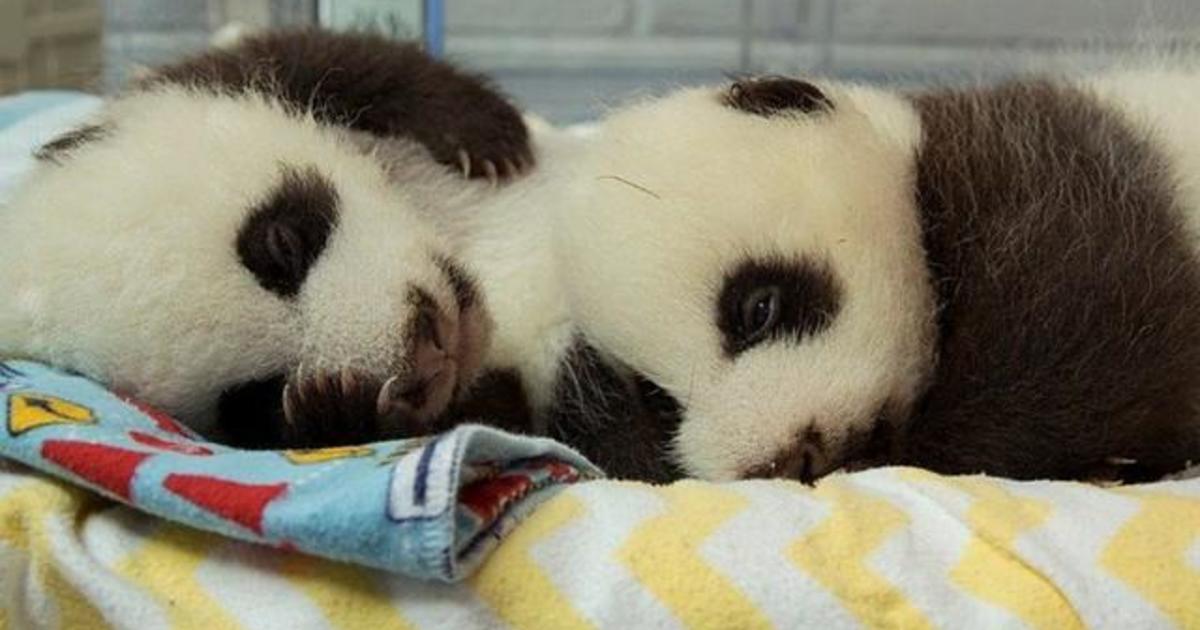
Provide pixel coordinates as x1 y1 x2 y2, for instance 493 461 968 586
907 82 1200 479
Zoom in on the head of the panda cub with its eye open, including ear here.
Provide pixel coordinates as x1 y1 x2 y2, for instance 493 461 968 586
556 78 935 480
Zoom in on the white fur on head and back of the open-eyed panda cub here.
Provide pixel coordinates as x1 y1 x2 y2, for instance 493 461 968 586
535 67 1200 479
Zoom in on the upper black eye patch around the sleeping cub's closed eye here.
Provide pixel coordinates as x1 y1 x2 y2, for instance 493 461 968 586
238 167 338 298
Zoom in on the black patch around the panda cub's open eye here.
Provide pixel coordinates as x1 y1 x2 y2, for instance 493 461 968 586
716 257 841 358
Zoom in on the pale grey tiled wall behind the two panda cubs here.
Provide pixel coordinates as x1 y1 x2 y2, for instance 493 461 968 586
100 0 1200 120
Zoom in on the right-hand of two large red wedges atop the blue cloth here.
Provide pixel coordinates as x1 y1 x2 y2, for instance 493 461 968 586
162 473 288 535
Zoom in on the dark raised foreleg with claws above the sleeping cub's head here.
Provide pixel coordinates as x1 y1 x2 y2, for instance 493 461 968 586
139 29 533 179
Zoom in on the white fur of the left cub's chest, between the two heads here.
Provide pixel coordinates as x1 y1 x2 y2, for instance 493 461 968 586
410 119 589 432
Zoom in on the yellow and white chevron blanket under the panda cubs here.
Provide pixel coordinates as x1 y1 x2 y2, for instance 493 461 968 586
0 456 1200 630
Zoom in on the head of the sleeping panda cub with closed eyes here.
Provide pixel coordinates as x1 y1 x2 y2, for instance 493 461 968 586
9 86 491 446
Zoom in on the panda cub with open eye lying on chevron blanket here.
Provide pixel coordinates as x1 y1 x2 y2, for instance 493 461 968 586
554 70 1200 480
